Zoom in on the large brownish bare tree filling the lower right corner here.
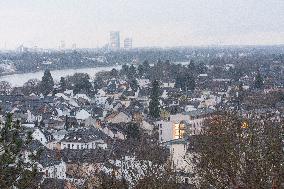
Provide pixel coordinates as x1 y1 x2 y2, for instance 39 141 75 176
194 113 284 188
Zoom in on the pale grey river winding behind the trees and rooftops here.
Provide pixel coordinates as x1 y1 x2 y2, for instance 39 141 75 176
0 65 121 87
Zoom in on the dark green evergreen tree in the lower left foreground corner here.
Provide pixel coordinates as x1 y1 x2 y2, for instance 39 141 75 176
0 113 39 188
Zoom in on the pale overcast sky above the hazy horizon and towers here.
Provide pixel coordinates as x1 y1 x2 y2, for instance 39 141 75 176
0 0 284 48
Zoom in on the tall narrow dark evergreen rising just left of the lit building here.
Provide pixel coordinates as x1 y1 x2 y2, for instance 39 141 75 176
149 80 160 118
